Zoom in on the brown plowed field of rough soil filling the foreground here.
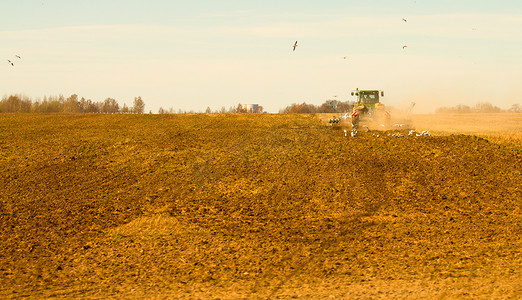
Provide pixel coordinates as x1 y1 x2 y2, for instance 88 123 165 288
0 114 522 299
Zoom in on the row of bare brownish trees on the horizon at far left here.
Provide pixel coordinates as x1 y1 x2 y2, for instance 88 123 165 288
0 94 145 114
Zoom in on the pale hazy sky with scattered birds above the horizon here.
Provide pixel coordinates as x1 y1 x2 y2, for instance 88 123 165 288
0 0 522 113
